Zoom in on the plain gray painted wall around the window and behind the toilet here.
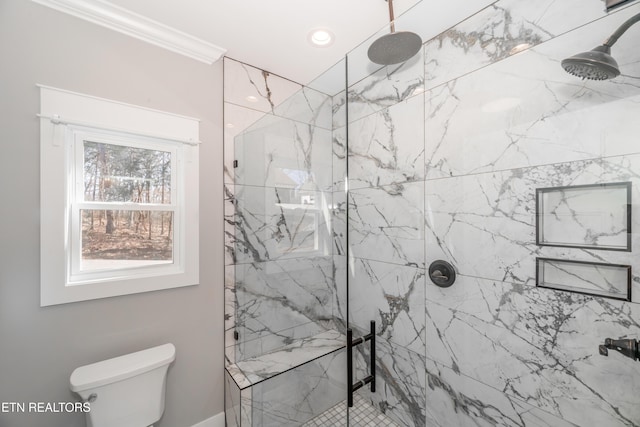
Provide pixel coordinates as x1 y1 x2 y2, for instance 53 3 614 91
0 0 224 427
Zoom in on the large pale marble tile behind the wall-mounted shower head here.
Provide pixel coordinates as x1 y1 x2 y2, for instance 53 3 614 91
425 6 640 178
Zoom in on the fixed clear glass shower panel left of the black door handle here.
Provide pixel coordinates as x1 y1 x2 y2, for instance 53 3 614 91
224 58 346 426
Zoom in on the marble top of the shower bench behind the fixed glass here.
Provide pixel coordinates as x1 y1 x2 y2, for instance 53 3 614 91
227 329 346 390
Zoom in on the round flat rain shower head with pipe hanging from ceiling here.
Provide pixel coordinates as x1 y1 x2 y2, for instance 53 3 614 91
367 0 422 65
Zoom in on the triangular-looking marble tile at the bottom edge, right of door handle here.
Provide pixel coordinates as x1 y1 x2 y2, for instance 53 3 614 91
427 359 577 427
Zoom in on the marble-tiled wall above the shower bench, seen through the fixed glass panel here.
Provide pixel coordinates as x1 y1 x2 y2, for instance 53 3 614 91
224 58 336 363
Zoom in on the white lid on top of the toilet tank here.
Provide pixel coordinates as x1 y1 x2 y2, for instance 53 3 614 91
69 343 176 392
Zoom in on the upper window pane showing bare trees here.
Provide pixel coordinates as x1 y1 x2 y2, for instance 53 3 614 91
84 141 171 204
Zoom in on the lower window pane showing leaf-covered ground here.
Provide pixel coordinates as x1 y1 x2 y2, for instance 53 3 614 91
80 210 173 271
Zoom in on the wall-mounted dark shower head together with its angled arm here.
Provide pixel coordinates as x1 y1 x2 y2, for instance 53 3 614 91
562 13 640 80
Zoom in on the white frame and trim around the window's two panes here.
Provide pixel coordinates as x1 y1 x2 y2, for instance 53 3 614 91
39 85 199 306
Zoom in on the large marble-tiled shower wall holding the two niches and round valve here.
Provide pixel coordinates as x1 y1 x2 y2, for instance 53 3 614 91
344 0 640 427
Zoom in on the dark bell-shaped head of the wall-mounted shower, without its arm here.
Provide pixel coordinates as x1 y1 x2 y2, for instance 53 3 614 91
562 45 620 80
